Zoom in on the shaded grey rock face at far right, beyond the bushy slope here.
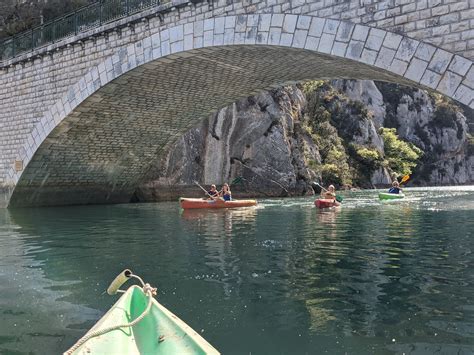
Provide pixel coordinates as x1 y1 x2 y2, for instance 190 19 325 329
378 83 474 185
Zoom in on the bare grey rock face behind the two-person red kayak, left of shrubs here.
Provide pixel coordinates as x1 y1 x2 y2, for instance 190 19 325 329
137 87 320 200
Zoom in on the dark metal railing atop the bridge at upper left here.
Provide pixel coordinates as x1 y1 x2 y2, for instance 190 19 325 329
0 0 161 61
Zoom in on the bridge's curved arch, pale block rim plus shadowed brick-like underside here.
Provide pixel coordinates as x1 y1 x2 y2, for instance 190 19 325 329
8 14 474 205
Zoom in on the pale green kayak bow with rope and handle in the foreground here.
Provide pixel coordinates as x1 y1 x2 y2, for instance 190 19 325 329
65 272 219 355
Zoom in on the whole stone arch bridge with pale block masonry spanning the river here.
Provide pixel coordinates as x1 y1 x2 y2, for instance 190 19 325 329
0 0 474 207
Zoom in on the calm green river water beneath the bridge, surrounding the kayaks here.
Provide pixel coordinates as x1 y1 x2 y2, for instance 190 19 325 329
0 187 474 354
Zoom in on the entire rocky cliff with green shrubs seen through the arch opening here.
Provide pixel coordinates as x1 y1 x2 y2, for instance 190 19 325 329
135 80 474 200
